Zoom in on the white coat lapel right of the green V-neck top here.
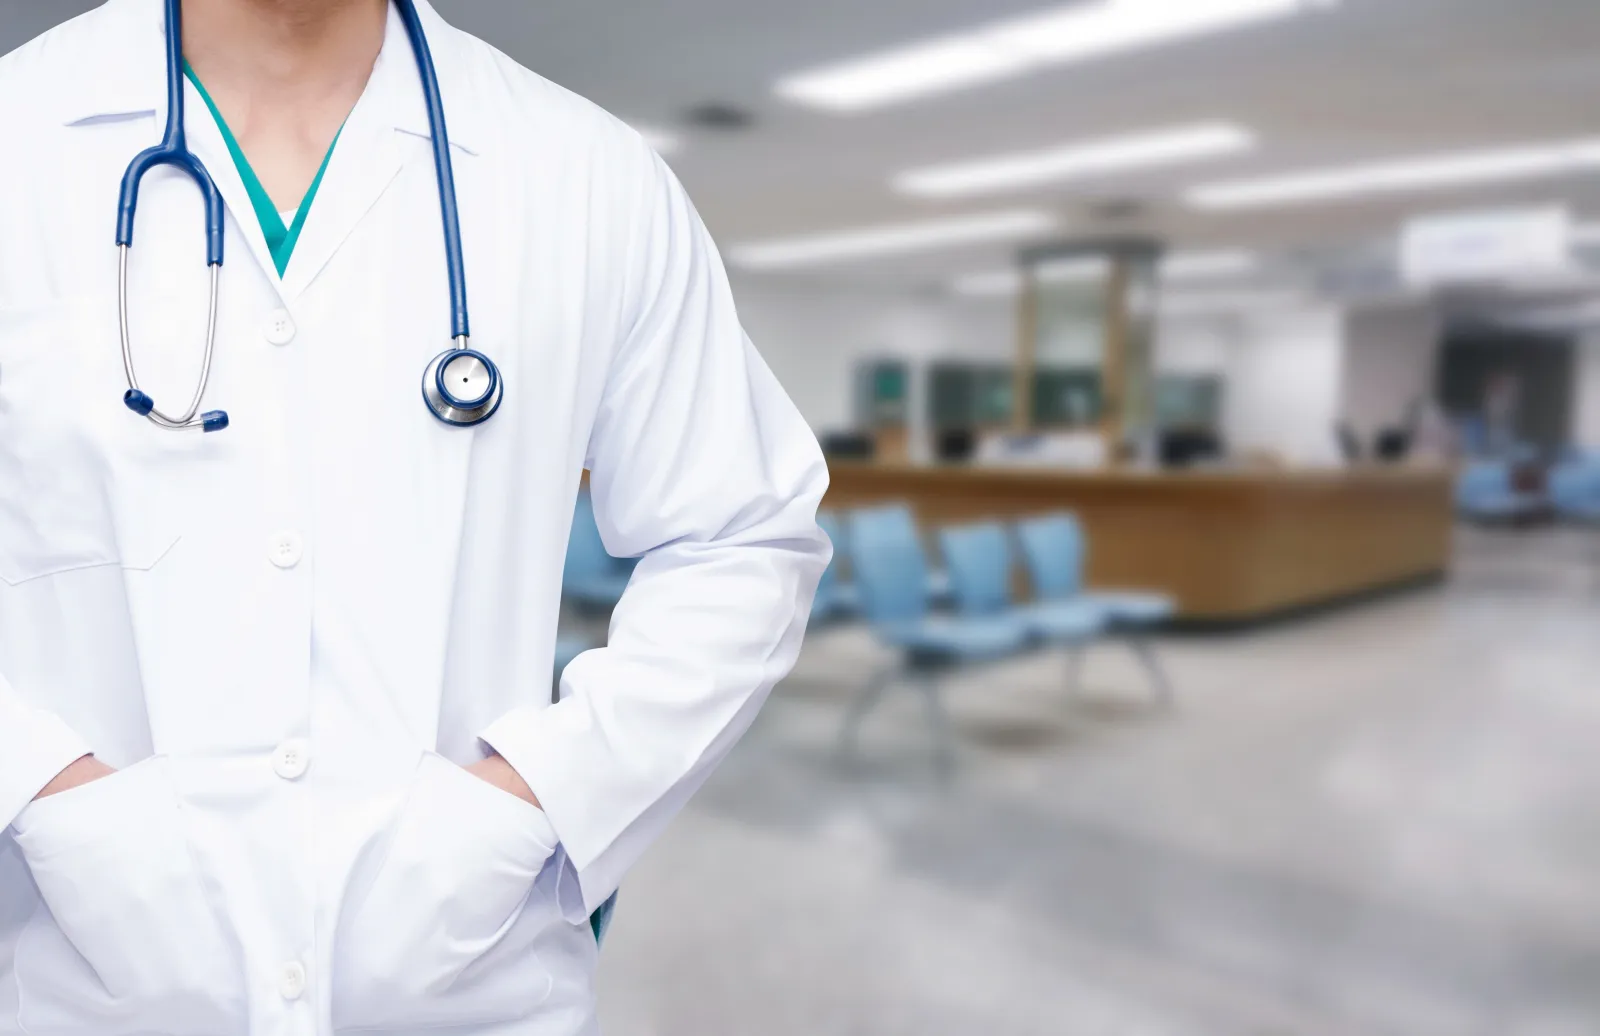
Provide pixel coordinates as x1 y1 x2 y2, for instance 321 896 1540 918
283 8 421 301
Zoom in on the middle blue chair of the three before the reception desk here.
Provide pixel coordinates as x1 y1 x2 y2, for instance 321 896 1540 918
939 521 1106 692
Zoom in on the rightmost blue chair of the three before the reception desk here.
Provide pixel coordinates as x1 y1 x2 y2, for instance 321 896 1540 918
1016 513 1176 705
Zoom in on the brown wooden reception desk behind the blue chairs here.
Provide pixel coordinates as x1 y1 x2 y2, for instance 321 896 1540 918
824 462 1453 624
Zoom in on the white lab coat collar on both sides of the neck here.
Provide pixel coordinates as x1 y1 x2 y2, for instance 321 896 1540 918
50 0 491 158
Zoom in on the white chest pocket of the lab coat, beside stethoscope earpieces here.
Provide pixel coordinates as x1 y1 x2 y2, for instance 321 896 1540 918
0 299 184 585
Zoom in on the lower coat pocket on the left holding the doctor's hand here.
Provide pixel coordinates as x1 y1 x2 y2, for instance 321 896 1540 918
14 758 246 1036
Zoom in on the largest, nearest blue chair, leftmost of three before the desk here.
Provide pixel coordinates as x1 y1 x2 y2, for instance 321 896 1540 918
838 505 1029 771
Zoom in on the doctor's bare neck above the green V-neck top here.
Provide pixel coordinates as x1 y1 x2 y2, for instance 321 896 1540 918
184 0 389 104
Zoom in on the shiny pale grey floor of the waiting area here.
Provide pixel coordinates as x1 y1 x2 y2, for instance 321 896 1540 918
602 531 1600 1036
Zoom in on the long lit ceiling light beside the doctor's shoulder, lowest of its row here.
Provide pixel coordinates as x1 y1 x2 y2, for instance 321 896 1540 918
728 209 1056 270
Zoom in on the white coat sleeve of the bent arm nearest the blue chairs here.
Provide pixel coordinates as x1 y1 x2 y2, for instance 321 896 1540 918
483 143 832 910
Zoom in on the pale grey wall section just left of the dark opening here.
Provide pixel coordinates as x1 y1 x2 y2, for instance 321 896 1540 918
1339 302 1443 441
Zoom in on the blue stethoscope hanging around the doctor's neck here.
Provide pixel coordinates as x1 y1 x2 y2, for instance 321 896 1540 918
117 0 506 432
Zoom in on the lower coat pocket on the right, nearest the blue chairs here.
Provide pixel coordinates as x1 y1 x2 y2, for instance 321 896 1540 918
333 753 555 1030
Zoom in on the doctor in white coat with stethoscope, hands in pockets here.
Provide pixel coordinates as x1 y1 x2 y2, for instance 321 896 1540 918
0 0 829 1036
